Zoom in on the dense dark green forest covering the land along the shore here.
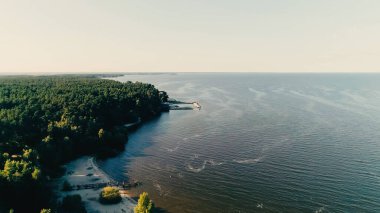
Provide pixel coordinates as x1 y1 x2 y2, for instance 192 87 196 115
0 76 167 211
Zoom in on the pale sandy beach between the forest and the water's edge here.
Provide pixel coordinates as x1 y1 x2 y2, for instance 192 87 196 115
54 156 136 213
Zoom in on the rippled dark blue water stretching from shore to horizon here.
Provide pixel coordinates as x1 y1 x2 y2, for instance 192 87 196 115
100 73 380 212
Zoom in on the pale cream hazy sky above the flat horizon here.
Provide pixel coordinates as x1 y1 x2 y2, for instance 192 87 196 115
0 0 380 74
